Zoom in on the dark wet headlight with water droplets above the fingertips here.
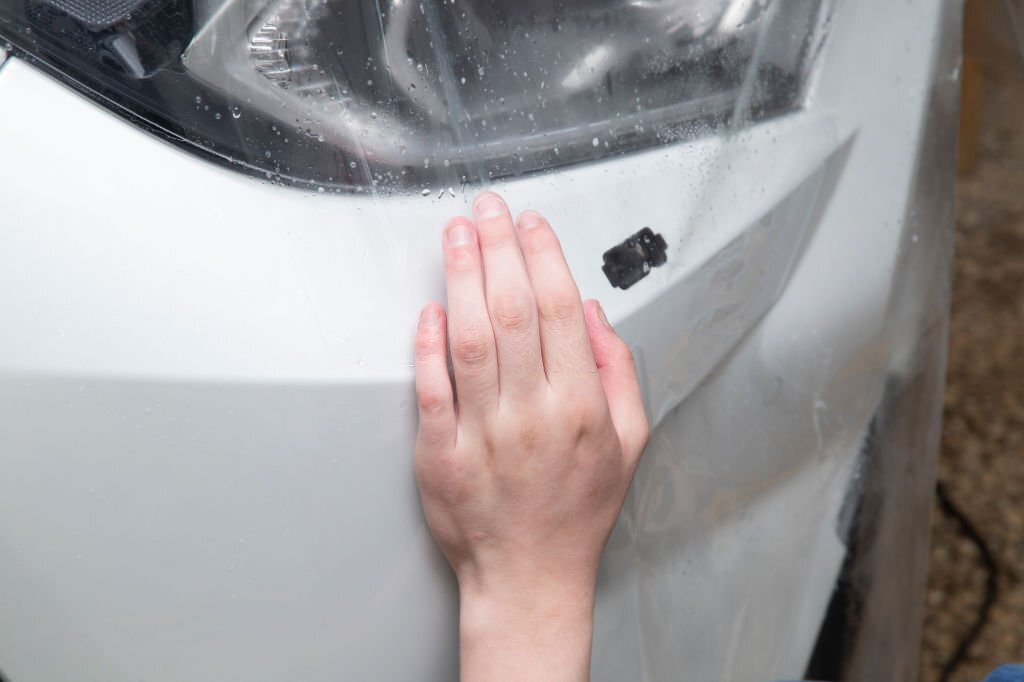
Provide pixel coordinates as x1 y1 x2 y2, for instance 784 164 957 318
0 0 826 193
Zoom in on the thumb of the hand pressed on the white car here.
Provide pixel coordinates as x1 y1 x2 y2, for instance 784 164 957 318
584 300 649 459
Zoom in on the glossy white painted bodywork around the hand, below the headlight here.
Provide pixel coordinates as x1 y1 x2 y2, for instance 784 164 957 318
0 0 942 682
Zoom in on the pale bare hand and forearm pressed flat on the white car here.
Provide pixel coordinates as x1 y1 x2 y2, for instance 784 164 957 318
415 188 648 682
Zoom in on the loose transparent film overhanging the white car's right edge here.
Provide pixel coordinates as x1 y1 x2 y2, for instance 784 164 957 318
808 2 963 680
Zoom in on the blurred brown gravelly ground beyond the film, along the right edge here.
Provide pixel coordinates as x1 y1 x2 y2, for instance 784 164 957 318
921 0 1024 682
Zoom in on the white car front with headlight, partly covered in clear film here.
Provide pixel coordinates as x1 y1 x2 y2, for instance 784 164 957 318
0 0 959 682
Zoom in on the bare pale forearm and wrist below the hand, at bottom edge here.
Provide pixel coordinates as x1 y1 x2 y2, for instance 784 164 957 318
459 585 594 682
